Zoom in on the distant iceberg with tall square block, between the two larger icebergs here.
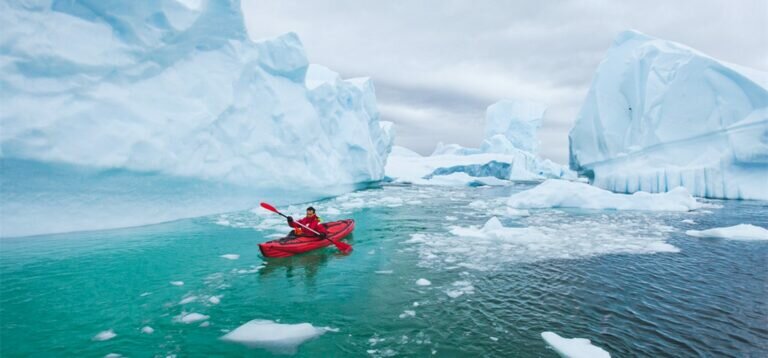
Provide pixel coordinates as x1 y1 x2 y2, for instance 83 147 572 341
386 100 576 185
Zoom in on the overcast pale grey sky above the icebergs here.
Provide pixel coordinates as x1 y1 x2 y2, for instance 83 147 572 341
243 0 768 163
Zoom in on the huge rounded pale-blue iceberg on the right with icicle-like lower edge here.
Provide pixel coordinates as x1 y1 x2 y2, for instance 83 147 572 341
570 31 768 200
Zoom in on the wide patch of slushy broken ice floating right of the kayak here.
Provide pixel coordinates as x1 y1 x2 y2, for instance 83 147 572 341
405 210 679 271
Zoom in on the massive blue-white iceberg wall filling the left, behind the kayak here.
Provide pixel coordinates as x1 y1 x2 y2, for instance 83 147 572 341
0 0 392 236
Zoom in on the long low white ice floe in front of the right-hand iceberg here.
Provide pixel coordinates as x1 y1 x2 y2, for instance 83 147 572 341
507 179 704 211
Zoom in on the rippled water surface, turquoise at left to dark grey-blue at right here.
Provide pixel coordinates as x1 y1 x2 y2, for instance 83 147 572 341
0 184 768 357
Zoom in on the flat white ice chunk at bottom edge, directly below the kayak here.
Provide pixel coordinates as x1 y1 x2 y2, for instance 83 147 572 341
221 319 328 354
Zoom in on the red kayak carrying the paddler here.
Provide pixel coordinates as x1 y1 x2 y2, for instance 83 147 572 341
259 219 355 257
